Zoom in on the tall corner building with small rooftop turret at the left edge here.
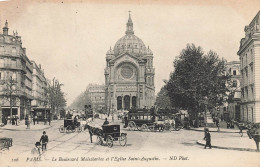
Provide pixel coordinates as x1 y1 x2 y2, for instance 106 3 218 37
0 21 32 120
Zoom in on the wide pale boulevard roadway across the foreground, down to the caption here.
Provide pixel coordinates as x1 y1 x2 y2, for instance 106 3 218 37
0 115 259 166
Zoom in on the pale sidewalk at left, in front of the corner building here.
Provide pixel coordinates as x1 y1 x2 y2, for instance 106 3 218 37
0 120 53 131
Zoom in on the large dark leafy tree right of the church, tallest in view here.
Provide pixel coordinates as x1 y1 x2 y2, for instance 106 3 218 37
166 44 230 116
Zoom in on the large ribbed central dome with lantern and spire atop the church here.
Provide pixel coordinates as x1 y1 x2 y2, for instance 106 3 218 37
114 14 147 56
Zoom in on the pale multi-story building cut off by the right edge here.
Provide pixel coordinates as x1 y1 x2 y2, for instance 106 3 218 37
237 11 260 122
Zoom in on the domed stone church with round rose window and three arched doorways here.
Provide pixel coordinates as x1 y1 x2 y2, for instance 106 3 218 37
104 13 155 110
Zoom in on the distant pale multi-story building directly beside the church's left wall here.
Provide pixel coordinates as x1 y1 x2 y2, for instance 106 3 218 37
87 84 105 111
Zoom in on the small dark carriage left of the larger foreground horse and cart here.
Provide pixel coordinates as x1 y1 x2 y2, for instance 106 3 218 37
59 119 83 133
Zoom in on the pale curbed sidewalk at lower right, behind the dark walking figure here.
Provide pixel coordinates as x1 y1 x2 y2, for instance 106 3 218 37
197 136 259 152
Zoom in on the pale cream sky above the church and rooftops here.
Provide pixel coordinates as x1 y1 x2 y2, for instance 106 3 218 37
0 0 260 105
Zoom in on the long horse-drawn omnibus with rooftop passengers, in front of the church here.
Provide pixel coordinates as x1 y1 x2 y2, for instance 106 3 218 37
127 111 181 132
